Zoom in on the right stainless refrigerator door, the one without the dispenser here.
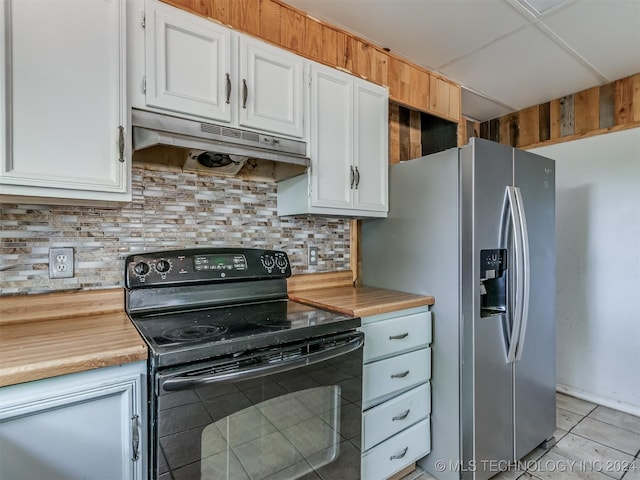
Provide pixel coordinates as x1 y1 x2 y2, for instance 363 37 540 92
514 150 556 459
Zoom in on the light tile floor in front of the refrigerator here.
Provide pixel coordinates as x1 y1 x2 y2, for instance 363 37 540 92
402 393 640 480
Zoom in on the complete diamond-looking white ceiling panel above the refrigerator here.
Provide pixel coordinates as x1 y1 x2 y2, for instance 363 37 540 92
442 26 600 110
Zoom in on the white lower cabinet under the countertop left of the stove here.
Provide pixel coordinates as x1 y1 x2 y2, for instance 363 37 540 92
0 362 147 480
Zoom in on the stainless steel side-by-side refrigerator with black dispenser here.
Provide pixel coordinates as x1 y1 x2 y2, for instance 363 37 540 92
362 138 556 480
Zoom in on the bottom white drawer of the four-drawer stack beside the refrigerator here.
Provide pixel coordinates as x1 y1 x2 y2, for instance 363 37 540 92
362 418 431 480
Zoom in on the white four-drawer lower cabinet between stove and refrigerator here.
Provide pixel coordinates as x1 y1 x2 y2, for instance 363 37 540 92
361 307 431 480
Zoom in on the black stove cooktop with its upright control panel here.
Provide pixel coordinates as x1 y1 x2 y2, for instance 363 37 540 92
125 248 360 367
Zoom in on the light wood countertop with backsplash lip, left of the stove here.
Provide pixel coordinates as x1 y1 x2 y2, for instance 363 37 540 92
0 289 147 386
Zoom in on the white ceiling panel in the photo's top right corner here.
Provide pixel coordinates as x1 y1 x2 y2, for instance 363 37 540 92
543 0 640 82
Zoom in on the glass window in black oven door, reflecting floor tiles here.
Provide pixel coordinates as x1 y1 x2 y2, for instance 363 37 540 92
201 386 341 478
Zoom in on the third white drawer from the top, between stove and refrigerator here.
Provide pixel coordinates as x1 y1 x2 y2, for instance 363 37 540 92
362 383 431 450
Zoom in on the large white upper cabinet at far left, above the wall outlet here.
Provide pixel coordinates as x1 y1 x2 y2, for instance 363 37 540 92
0 0 131 204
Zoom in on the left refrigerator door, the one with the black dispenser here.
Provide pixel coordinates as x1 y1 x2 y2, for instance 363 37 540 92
460 139 513 480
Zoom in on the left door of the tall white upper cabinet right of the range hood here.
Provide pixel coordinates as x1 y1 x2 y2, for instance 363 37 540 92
310 64 355 208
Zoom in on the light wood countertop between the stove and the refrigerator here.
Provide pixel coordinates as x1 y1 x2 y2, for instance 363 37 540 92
289 286 435 317
